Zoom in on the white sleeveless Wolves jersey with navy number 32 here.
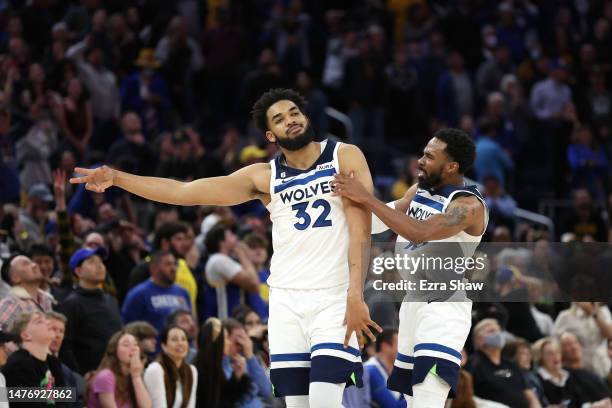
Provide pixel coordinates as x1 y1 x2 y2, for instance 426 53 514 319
267 140 349 289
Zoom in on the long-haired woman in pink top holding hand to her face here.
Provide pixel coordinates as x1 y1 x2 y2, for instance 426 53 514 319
87 330 151 408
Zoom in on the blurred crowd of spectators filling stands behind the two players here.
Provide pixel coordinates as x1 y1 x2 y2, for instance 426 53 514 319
0 0 612 408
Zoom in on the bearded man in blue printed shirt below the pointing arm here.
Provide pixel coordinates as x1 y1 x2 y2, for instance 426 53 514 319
121 251 191 333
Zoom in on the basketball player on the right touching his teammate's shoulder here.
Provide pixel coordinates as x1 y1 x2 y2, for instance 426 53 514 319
334 129 488 408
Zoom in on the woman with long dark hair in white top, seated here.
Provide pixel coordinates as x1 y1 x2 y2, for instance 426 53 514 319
144 326 198 408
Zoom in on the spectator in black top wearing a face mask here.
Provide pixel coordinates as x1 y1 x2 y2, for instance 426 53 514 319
466 318 540 408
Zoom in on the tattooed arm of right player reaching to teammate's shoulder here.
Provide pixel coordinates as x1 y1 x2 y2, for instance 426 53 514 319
334 175 484 243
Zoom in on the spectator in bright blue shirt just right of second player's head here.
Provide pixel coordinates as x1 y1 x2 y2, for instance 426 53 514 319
474 120 514 186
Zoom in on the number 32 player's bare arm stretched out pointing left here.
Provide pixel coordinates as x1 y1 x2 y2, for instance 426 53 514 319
70 163 270 205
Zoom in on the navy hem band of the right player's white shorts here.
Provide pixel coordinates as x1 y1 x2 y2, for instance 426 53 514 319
387 356 460 398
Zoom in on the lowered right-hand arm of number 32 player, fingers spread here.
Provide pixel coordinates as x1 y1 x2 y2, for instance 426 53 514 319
338 144 382 347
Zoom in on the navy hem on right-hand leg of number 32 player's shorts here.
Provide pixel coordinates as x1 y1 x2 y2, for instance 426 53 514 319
310 355 363 388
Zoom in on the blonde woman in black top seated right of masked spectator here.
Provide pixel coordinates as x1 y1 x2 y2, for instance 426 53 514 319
533 337 611 408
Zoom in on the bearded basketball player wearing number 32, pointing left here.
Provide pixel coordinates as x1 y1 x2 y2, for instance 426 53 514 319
70 89 382 408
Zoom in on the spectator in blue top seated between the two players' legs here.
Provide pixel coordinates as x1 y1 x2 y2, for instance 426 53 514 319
363 329 406 408
